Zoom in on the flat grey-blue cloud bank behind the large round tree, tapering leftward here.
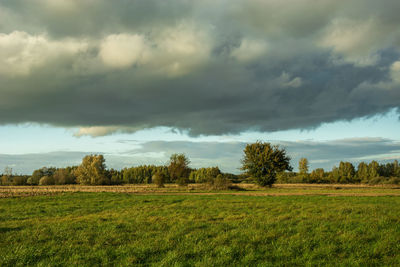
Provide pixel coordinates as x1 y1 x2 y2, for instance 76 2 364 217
127 138 400 173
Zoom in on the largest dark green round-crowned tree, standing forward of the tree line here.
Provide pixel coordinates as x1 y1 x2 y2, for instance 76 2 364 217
241 141 292 187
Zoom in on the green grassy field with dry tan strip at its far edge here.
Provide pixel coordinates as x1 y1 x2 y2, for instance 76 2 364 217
0 185 400 266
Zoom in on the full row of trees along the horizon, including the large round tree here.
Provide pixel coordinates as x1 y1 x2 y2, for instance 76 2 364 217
0 141 400 188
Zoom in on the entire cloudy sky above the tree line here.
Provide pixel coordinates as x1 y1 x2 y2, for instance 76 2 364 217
0 0 400 174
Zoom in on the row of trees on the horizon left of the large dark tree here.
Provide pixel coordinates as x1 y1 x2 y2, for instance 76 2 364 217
0 154 240 186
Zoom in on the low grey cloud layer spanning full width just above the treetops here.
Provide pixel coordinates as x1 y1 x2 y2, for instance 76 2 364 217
0 138 400 174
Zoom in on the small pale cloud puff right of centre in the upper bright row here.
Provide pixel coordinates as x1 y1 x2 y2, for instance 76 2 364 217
231 39 267 62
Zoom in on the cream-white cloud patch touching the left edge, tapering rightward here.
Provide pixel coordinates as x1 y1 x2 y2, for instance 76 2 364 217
0 31 88 76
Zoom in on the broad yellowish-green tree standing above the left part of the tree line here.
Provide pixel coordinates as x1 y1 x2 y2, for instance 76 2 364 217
74 155 110 185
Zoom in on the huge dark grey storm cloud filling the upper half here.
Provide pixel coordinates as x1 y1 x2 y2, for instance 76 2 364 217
0 0 400 136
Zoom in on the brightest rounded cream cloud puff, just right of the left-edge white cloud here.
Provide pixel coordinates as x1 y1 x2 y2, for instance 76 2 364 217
99 34 149 68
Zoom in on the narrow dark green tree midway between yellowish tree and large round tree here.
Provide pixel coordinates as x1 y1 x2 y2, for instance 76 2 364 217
168 154 190 185
